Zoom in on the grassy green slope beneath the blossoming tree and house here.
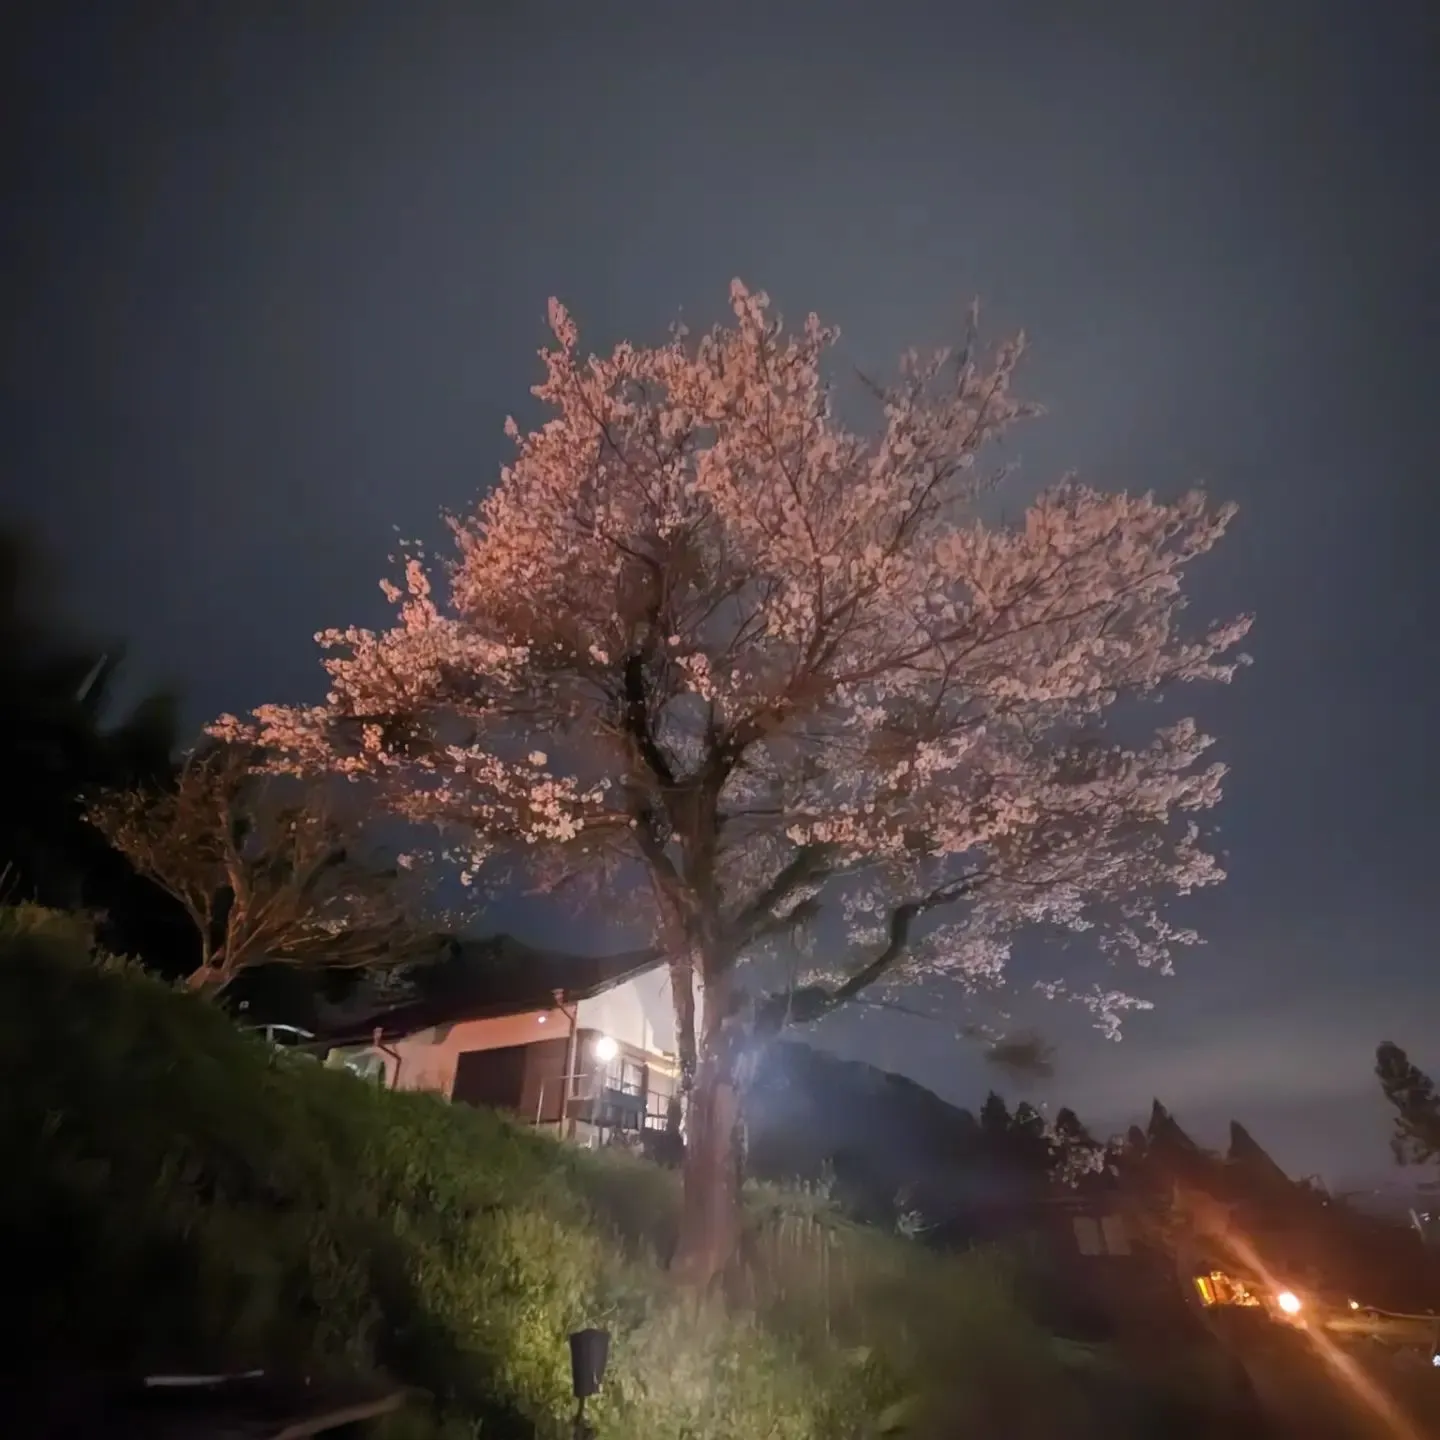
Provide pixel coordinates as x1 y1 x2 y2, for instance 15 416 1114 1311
0 910 1238 1440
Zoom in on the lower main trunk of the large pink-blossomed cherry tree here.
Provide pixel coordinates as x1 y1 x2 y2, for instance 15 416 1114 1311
671 978 749 1290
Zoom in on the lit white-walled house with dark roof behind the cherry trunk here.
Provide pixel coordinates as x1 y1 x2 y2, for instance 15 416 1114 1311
307 936 678 1145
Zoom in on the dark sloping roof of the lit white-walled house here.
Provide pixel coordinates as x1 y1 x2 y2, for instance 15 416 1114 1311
312 935 658 1045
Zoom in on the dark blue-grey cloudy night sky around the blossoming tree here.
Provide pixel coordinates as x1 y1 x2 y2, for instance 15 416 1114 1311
0 0 1440 1181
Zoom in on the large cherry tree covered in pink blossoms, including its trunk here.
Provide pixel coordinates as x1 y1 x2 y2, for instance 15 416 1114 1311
217 282 1247 1283
